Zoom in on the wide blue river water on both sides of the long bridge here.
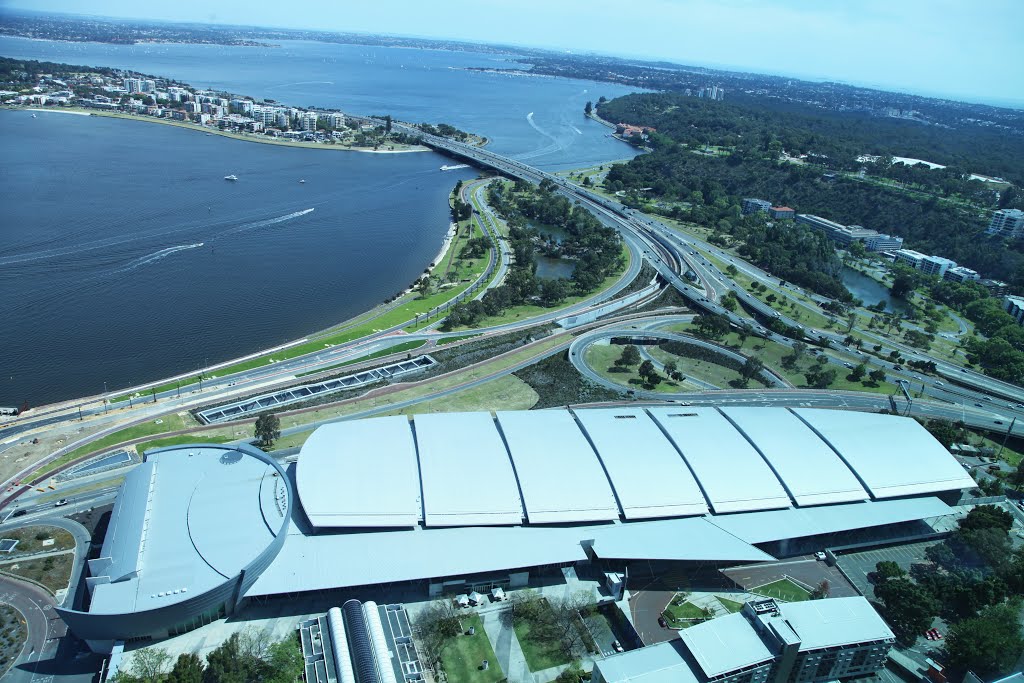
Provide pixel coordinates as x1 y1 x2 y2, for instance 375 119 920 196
0 37 634 404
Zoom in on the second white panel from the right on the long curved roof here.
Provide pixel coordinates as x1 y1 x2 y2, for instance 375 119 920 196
722 408 869 505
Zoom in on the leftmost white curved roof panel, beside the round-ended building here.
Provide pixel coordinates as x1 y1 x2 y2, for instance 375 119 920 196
295 415 423 526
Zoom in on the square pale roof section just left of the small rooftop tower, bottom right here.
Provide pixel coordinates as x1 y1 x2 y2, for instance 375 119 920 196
679 613 775 678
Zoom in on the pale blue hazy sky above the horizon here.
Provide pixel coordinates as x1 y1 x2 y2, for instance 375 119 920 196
0 0 1024 106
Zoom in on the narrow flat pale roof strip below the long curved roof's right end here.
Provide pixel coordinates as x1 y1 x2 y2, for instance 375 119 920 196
708 498 953 543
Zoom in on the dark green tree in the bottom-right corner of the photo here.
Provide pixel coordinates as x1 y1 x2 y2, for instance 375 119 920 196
946 604 1024 677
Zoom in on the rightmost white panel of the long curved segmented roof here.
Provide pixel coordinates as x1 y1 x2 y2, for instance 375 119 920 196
793 408 977 498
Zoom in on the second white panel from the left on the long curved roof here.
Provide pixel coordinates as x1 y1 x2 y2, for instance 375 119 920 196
409 413 522 526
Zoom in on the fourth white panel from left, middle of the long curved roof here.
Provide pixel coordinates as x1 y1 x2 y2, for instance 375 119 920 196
575 408 708 519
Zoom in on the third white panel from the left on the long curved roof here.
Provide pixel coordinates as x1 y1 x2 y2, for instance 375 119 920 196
497 411 618 524
